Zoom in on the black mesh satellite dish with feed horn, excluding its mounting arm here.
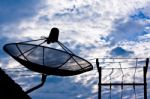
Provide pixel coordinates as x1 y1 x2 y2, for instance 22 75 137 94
4 28 93 76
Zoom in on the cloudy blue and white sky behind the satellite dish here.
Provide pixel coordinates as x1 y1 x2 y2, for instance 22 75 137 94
0 0 150 99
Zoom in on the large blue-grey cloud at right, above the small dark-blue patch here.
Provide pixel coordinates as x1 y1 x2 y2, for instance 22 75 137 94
107 18 150 44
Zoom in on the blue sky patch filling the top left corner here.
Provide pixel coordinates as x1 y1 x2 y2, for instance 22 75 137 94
0 0 41 25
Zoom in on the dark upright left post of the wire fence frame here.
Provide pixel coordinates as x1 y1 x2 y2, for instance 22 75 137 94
96 59 102 99
